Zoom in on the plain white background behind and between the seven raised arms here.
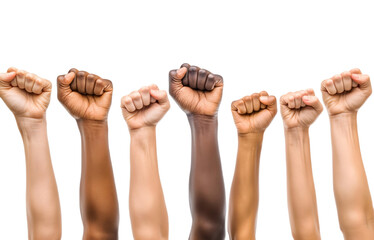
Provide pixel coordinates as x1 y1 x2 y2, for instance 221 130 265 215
0 0 374 240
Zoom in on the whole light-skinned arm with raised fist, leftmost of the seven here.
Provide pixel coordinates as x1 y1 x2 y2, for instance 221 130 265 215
0 68 61 240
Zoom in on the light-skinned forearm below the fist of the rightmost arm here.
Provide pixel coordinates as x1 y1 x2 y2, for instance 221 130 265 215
330 113 374 231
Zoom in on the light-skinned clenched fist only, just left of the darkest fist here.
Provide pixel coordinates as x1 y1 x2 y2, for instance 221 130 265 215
121 85 170 130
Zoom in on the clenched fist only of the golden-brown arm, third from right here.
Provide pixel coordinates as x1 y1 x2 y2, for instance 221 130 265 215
231 91 277 134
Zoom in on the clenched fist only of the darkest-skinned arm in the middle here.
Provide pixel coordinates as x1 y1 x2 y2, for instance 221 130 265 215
169 63 223 116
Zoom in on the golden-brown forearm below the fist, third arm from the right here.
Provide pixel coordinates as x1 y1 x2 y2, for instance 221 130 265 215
229 133 263 240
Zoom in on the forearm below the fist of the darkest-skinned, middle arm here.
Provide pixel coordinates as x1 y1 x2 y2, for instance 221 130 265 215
188 115 225 239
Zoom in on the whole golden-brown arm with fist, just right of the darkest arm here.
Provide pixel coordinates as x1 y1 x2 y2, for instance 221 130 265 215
228 91 277 240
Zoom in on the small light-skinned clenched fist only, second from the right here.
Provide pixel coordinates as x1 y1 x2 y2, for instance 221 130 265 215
280 89 323 129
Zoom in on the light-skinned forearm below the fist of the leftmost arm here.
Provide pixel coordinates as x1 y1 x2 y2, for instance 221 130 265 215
17 118 61 239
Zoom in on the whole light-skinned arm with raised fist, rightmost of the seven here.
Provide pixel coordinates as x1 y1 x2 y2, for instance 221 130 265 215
321 69 374 240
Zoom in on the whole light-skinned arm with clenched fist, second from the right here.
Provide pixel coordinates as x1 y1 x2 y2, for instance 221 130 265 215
280 89 323 240
